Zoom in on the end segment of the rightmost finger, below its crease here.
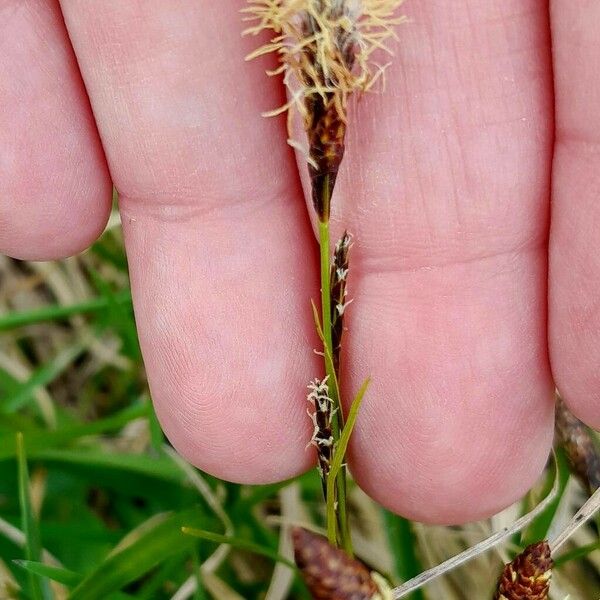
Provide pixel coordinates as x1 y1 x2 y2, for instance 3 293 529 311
548 145 600 429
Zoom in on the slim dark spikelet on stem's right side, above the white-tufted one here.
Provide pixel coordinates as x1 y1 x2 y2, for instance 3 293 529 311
329 231 352 380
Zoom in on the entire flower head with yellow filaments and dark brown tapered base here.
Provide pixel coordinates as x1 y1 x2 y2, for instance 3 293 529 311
244 0 404 221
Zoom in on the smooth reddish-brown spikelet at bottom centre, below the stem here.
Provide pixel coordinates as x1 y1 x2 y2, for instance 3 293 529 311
292 527 383 600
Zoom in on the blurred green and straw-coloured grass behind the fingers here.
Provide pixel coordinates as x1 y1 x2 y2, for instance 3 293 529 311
0 204 600 600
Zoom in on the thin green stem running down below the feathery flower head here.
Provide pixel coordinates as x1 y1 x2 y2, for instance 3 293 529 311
319 202 353 556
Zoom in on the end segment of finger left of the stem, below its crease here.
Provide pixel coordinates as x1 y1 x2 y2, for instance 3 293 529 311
124 199 318 483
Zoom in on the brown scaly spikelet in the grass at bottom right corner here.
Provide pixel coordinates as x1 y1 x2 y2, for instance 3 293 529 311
494 541 553 600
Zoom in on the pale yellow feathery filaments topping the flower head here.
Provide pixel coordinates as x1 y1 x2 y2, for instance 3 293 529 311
244 0 405 125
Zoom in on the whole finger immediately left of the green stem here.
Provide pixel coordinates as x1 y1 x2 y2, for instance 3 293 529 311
57 0 317 482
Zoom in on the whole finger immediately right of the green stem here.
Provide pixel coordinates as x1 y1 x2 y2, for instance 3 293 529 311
334 0 553 522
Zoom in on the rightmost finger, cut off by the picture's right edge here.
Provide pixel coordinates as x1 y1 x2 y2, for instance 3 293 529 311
549 0 600 427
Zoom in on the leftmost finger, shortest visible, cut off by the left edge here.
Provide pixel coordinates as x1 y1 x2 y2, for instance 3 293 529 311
0 0 111 260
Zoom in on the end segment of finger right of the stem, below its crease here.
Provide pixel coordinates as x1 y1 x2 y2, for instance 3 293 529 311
348 250 553 523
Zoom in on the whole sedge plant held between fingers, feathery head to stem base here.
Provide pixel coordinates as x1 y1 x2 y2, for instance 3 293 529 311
245 0 403 556
